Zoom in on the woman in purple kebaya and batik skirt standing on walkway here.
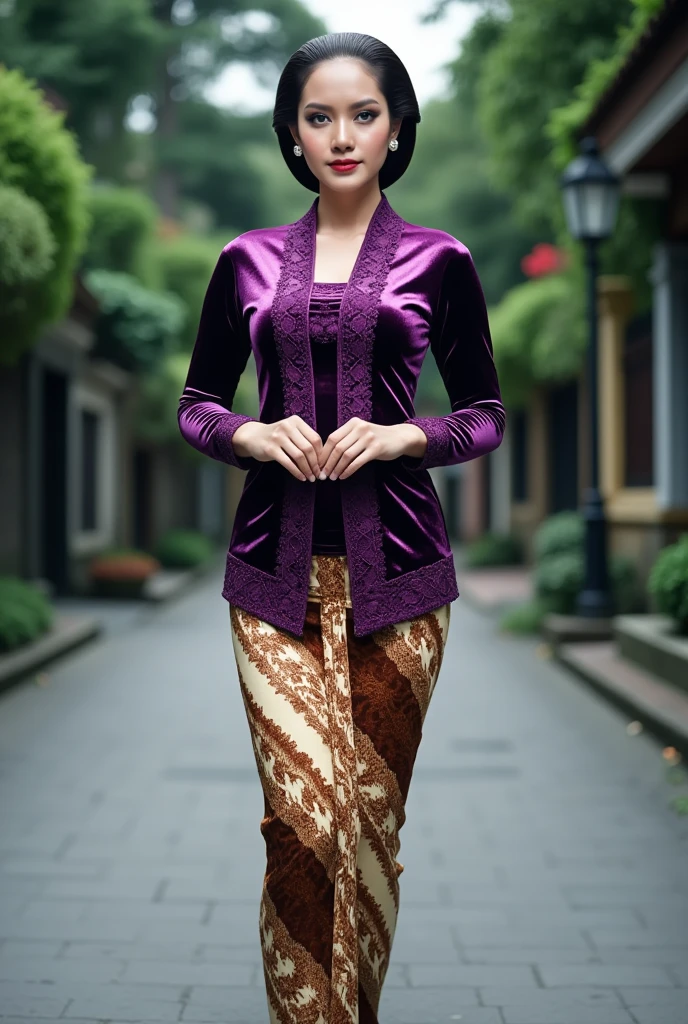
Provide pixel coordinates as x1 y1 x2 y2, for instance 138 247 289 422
179 33 505 1024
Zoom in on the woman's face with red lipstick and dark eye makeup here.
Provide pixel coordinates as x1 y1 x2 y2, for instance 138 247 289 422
291 57 401 191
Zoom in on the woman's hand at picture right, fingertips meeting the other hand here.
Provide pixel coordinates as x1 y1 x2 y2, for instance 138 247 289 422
318 416 428 480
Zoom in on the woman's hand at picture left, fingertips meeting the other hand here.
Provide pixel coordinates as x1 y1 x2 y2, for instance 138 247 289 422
231 414 323 481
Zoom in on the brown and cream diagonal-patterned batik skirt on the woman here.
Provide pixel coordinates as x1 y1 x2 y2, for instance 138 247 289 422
229 555 450 1024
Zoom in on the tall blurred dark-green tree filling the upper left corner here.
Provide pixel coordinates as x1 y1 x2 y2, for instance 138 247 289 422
0 0 326 226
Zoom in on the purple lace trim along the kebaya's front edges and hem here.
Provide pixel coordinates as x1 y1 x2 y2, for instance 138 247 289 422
258 194 458 636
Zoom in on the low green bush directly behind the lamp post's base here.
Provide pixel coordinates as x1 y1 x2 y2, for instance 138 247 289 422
533 546 637 615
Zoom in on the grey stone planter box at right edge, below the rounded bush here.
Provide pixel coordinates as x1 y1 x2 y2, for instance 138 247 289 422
613 615 688 691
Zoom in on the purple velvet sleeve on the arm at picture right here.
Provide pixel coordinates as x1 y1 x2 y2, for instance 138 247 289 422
401 240 506 470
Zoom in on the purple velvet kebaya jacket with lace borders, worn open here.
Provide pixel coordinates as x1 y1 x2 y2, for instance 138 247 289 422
179 193 505 636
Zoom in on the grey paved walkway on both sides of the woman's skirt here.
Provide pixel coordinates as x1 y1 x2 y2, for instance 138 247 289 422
0 577 688 1024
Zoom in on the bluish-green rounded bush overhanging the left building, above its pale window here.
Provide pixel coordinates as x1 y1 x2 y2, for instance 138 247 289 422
85 270 186 373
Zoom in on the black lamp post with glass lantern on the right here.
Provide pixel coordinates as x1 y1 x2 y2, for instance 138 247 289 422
560 136 620 618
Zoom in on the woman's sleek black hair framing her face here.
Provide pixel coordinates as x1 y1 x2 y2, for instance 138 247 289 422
272 32 421 193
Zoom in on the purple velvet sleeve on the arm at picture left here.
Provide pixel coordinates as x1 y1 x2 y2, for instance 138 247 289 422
177 249 260 470
